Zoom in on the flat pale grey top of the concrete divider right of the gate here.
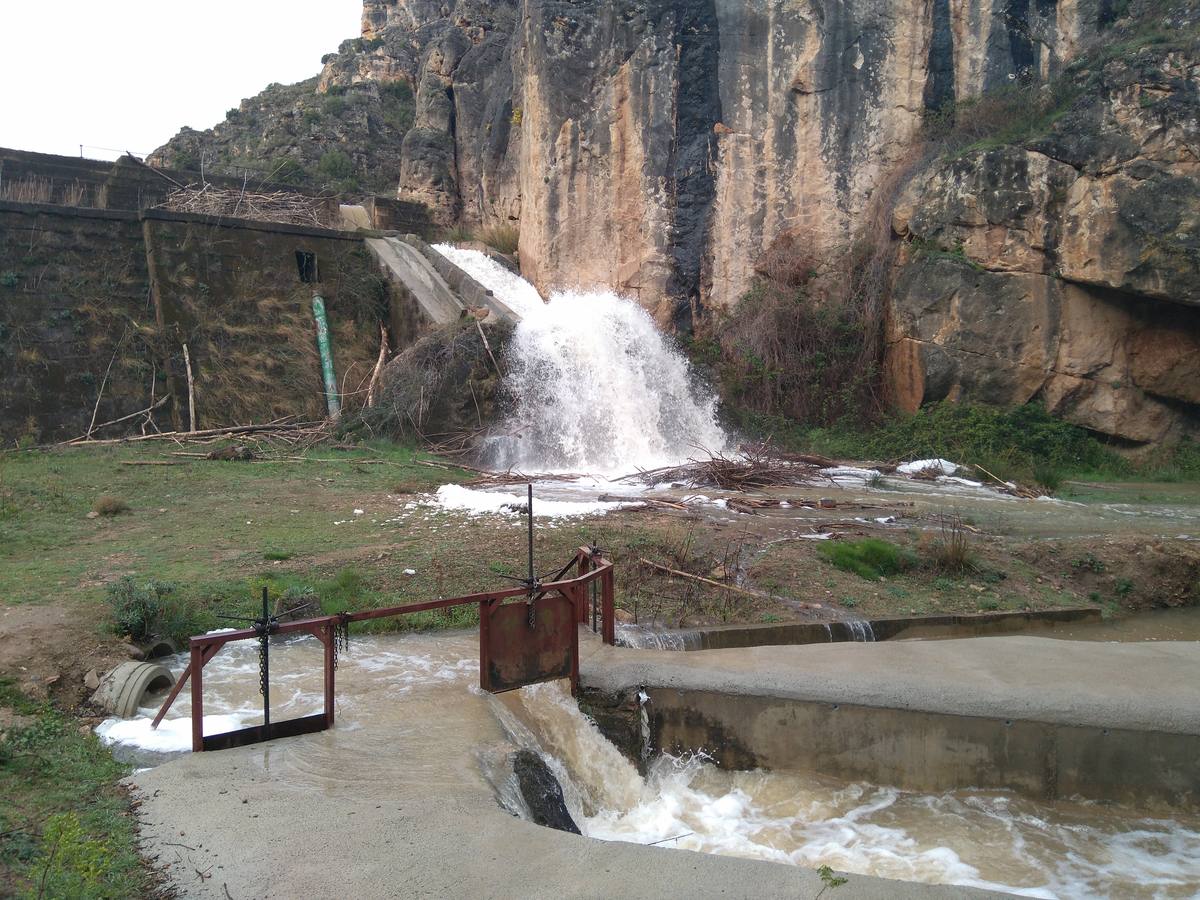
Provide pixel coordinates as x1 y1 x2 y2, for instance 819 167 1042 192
580 637 1200 736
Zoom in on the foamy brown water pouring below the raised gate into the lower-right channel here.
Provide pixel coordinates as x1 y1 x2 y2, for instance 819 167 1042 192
518 684 1200 900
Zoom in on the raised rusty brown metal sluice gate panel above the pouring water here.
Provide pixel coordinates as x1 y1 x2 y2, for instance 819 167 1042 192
479 594 580 694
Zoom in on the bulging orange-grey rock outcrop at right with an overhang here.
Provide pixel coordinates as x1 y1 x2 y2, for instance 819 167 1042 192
887 38 1200 444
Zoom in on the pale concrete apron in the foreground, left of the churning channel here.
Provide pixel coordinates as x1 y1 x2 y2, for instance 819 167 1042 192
133 676 997 900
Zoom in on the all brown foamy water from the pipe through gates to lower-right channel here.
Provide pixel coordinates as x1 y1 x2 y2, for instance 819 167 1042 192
100 634 1200 898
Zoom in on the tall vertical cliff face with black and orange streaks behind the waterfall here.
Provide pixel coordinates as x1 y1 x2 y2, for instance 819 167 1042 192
307 0 1104 329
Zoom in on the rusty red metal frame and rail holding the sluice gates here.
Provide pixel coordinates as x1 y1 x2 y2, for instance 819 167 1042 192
152 547 616 752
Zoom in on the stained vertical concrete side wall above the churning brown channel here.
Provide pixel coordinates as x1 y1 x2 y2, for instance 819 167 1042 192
648 688 1200 806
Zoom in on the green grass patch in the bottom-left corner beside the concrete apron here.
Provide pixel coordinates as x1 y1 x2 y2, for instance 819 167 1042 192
0 679 152 899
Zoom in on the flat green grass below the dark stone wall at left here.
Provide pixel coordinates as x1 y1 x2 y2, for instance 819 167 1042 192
0 442 469 602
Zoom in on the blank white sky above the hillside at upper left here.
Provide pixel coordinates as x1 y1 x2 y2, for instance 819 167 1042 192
0 0 362 160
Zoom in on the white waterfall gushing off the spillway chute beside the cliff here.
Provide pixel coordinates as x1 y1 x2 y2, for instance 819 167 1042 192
436 245 727 475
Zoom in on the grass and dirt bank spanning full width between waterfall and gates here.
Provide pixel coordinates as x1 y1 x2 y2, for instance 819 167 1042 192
0 448 1200 712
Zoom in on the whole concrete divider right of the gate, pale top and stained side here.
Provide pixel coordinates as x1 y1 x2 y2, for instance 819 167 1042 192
581 637 1200 806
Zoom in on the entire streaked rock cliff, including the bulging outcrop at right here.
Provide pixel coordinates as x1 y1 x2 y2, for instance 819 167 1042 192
154 0 1200 442
